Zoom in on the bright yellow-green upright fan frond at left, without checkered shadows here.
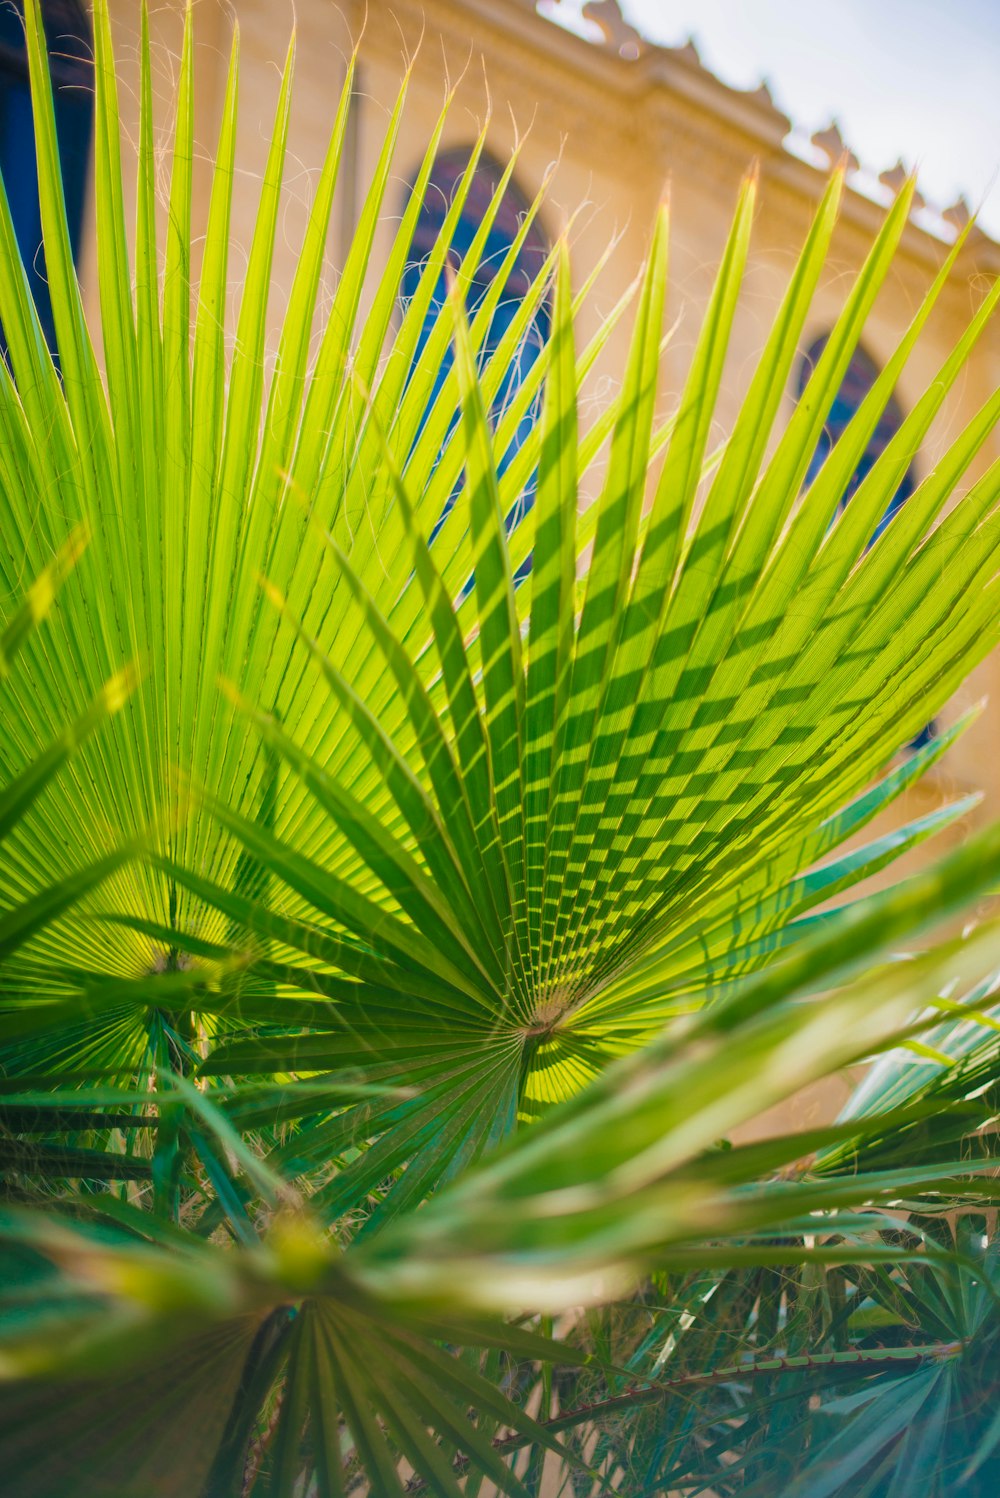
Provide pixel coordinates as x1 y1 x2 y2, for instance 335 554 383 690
0 0 609 1036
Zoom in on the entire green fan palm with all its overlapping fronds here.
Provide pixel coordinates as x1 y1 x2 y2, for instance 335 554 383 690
0 0 1000 1498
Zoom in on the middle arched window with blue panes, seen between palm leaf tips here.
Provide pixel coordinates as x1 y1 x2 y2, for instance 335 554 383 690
400 148 551 539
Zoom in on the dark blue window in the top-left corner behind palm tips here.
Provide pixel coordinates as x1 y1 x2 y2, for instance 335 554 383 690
0 0 94 356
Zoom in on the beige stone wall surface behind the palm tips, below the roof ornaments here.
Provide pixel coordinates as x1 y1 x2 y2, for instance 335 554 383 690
84 0 1000 813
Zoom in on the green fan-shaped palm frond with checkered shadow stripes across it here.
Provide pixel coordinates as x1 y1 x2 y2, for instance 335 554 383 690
203 155 1000 1207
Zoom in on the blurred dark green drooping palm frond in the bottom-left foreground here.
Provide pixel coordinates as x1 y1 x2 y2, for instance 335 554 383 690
0 1198 587 1498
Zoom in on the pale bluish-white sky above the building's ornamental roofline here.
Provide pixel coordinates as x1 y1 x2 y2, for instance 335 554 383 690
541 0 1000 238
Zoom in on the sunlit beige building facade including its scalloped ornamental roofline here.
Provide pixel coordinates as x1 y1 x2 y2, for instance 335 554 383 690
0 0 1000 815
